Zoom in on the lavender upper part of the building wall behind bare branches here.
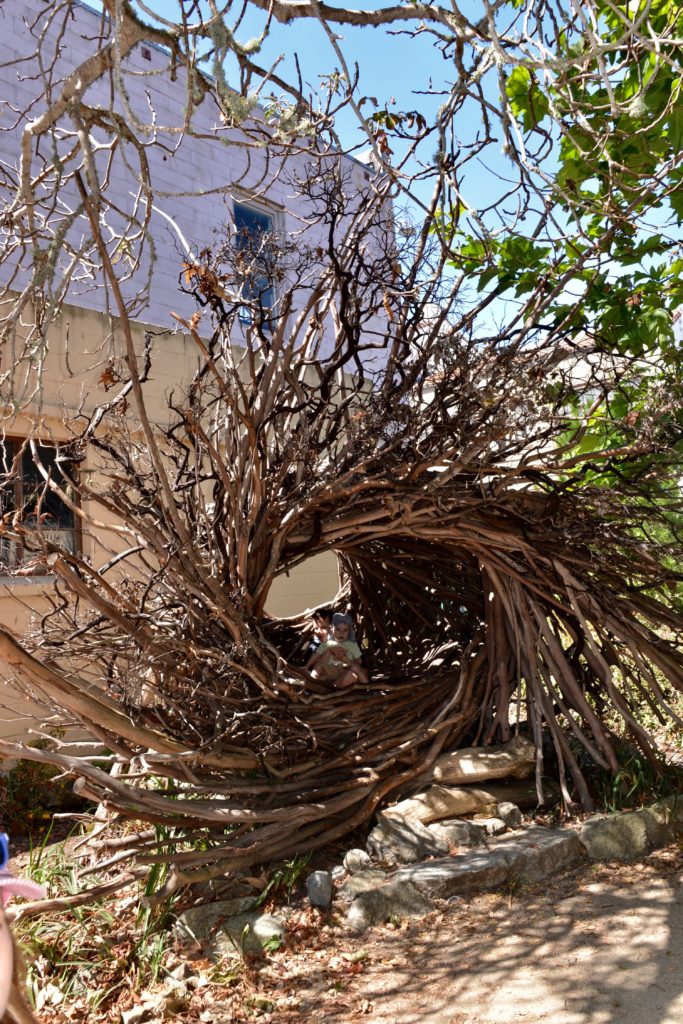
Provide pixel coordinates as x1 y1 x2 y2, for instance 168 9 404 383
0 0 371 328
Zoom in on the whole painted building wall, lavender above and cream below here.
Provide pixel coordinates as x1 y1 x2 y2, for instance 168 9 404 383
0 0 374 735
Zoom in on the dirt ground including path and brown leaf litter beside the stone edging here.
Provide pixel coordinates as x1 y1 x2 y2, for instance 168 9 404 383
223 847 683 1024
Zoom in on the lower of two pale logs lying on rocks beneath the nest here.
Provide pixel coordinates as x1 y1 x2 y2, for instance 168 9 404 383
382 781 559 824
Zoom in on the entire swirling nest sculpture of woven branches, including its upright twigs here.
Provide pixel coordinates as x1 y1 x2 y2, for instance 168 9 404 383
2 184 683 892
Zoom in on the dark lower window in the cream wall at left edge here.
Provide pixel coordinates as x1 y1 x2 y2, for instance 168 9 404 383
0 439 78 575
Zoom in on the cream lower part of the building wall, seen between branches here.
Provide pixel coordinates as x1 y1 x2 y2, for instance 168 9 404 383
0 306 338 738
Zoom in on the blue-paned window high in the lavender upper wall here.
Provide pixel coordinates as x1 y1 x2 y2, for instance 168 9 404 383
234 202 275 327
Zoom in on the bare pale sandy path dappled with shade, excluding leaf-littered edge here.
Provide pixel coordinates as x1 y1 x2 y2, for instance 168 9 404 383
322 851 683 1024
